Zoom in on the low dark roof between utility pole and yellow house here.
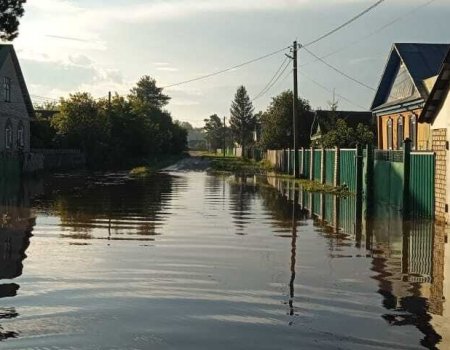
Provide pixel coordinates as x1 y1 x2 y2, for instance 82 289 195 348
311 110 375 135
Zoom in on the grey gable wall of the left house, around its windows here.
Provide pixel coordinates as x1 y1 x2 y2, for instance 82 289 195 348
0 53 30 152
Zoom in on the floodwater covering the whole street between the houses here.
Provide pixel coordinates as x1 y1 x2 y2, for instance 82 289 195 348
0 172 450 350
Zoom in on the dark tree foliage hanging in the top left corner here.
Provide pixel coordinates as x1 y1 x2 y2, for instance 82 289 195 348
0 0 26 41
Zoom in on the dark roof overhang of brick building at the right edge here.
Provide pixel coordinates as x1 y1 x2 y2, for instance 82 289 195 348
419 50 450 123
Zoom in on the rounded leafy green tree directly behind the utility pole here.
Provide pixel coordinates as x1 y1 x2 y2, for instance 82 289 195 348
260 90 311 149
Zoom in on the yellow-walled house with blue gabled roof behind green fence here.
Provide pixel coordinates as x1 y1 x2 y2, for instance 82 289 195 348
371 43 450 150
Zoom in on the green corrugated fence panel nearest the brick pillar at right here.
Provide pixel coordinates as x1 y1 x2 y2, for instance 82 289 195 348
409 153 435 218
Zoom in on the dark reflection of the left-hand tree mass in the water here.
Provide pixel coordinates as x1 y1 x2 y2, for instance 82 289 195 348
40 175 178 238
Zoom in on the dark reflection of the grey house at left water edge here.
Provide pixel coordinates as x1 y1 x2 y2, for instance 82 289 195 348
0 176 35 341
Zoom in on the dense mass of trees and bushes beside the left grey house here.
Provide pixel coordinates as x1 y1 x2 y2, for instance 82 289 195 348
31 76 187 168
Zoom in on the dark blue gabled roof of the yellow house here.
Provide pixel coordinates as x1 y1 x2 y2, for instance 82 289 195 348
371 43 450 110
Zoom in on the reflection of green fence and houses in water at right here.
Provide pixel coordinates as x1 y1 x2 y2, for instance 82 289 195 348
261 178 450 349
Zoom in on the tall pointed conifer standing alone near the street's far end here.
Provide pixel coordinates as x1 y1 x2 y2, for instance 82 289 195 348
230 86 256 157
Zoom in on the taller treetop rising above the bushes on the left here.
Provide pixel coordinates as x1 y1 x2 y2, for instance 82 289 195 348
129 75 170 109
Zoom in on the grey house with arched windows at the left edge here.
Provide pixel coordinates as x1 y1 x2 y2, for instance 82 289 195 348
0 44 34 153
